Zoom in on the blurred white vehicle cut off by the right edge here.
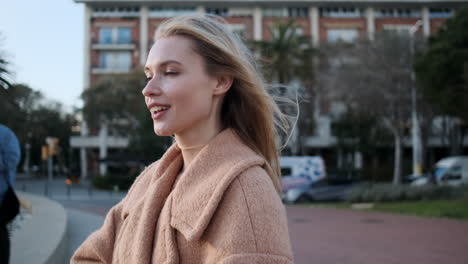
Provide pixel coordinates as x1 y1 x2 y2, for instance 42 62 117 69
434 156 468 186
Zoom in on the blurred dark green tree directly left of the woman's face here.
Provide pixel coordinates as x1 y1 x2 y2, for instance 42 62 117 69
82 68 171 162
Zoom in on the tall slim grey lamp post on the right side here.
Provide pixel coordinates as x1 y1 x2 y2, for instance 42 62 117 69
409 20 423 176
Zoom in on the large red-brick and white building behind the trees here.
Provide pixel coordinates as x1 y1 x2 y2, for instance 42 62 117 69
71 0 467 177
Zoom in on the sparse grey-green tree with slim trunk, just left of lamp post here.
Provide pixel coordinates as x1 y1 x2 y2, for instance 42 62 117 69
320 32 414 184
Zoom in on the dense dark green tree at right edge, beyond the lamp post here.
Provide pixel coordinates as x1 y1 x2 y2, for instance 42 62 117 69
415 8 468 123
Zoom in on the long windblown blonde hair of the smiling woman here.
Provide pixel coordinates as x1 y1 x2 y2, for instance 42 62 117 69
155 15 288 193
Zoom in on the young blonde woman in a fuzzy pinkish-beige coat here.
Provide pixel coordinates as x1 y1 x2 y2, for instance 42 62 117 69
71 15 293 264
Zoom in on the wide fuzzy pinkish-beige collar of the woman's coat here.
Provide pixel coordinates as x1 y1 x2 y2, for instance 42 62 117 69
163 129 265 241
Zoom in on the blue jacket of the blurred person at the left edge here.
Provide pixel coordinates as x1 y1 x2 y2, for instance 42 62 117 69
0 124 21 202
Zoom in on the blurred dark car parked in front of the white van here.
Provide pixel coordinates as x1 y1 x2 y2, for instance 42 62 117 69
282 179 357 203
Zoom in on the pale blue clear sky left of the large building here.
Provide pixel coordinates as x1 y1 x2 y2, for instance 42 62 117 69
0 0 84 111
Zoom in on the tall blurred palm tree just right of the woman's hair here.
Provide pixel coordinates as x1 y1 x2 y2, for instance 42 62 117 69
252 20 315 155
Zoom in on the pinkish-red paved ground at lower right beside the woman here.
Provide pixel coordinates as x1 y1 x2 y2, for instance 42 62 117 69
286 206 468 264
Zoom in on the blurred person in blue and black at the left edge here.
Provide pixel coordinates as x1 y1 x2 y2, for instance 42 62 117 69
0 124 21 264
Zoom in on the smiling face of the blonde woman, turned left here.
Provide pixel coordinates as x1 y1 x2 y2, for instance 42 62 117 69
143 36 218 136
